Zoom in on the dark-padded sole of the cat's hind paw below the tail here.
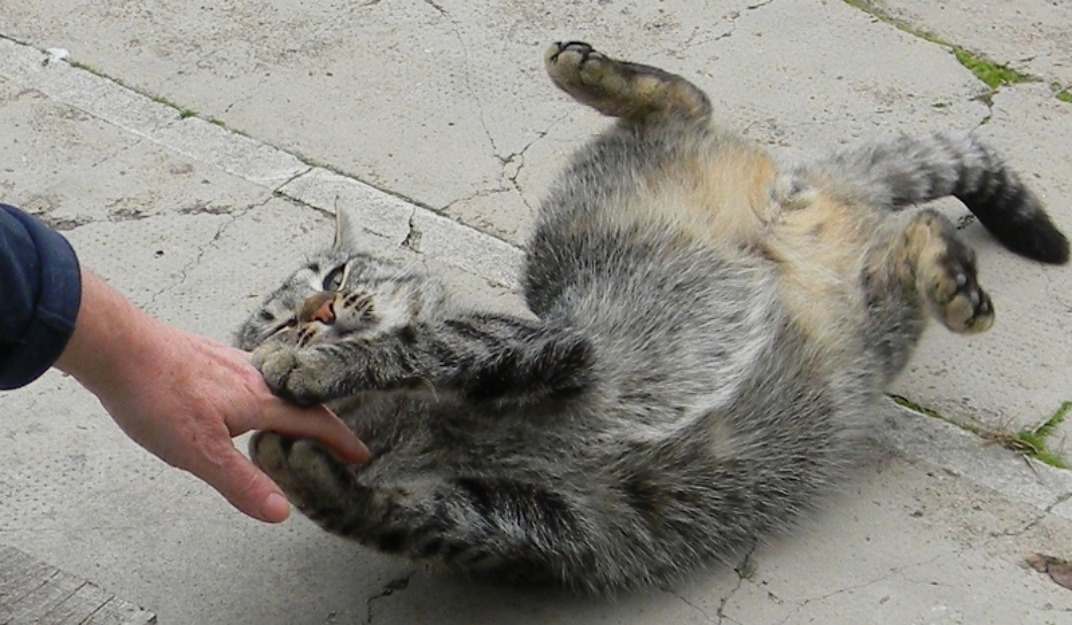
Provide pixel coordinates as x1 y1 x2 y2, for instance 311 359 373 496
927 250 994 333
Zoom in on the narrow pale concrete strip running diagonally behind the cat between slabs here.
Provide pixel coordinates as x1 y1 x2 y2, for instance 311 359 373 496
0 26 1072 531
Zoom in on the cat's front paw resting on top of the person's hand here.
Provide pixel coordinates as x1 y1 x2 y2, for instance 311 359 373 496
252 341 338 405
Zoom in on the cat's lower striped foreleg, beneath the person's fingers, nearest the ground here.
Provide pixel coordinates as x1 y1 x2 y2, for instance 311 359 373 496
250 432 621 590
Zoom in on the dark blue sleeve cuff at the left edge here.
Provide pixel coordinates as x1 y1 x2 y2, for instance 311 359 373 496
0 204 81 389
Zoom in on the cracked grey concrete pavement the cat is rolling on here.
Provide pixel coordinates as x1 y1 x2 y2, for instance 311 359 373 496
0 0 1072 625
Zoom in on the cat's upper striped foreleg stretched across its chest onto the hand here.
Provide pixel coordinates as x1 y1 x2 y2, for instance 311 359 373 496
253 314 594 404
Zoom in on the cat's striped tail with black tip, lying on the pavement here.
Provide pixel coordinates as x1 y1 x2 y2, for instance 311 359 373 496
805 133 1069 265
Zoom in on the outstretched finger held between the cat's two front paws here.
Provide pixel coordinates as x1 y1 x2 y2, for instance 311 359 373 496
259 399 370 464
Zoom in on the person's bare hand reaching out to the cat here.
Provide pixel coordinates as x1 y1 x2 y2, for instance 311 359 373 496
57 272 369 522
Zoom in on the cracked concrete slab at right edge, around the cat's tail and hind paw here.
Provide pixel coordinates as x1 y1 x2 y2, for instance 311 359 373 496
895 84 1072 441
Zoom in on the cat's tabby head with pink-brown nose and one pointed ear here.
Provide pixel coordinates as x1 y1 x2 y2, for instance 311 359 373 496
236 208 443 351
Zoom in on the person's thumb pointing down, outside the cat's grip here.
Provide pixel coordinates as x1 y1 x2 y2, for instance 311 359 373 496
190 444 291 523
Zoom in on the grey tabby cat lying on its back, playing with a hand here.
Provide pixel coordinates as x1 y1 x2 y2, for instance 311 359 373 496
238 42 1069 593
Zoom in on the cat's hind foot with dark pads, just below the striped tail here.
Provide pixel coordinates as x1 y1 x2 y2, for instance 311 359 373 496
893 210 994 333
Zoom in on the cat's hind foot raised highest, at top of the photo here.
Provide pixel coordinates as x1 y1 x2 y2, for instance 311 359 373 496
545 42 711 123
